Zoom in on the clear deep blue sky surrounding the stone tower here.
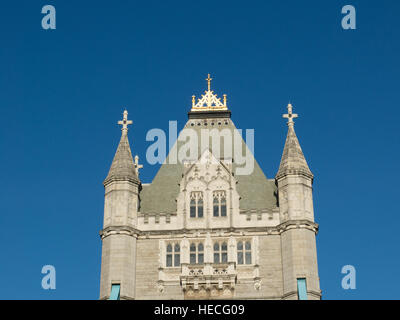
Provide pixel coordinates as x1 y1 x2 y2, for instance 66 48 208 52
0 0 400 299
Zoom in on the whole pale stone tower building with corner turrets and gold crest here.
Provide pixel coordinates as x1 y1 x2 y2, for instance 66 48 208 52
100 78 321 299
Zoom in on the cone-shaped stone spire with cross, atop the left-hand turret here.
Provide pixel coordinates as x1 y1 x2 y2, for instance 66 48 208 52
104 110 139 185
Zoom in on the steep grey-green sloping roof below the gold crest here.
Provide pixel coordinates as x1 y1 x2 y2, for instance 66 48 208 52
140 119 277 213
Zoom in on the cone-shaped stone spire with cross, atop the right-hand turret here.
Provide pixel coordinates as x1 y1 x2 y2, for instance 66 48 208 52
276 103 313 179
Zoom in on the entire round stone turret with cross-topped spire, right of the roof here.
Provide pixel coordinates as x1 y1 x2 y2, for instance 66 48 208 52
275 104 321 299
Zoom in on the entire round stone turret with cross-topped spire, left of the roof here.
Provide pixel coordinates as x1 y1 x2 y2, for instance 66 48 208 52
100 110 141 299
